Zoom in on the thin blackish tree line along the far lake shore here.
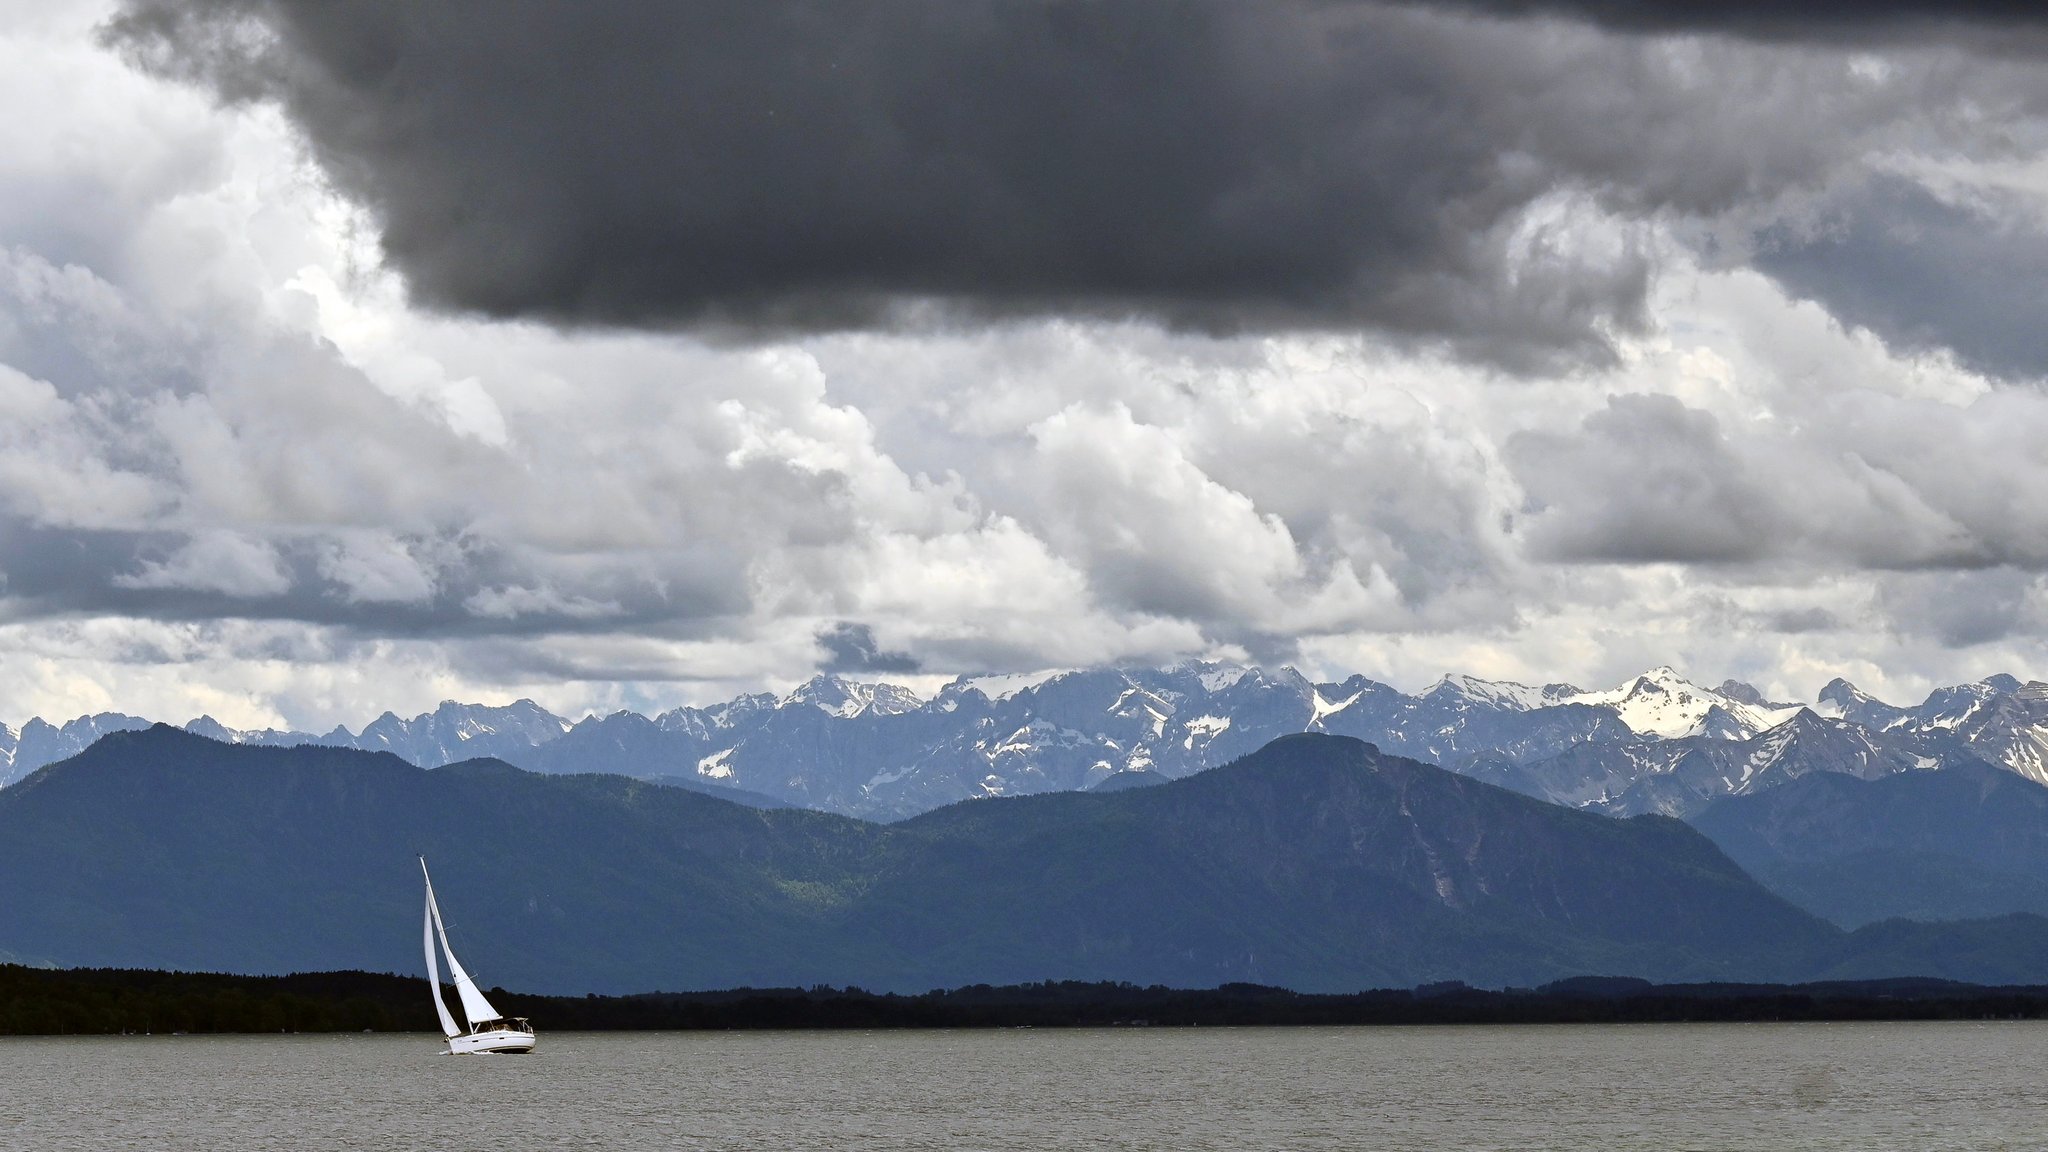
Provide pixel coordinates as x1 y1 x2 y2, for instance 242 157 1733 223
0 965 2048 1035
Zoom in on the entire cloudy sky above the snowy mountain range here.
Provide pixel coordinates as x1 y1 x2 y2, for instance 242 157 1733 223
0 0 2048 728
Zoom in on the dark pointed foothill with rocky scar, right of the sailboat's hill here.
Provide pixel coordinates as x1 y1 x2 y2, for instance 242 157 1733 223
851 736 1831 988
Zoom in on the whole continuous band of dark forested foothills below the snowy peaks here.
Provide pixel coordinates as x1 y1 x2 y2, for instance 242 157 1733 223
0 726 2048 992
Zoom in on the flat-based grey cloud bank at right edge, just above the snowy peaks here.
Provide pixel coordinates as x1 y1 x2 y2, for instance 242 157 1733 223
1505 385 2048 572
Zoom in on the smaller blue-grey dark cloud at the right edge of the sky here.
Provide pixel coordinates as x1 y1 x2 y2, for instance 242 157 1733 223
1755 176 2048 377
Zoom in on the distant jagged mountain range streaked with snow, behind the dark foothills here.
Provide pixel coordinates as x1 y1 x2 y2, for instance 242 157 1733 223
16 662 2048 820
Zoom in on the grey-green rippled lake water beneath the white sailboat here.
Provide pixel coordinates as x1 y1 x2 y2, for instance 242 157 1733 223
0 1023 2048 1152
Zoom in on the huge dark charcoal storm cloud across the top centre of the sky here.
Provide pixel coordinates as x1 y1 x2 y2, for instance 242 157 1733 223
96 0 1703 361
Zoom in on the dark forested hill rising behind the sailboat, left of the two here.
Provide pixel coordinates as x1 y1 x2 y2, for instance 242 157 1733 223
0 726 879 990
